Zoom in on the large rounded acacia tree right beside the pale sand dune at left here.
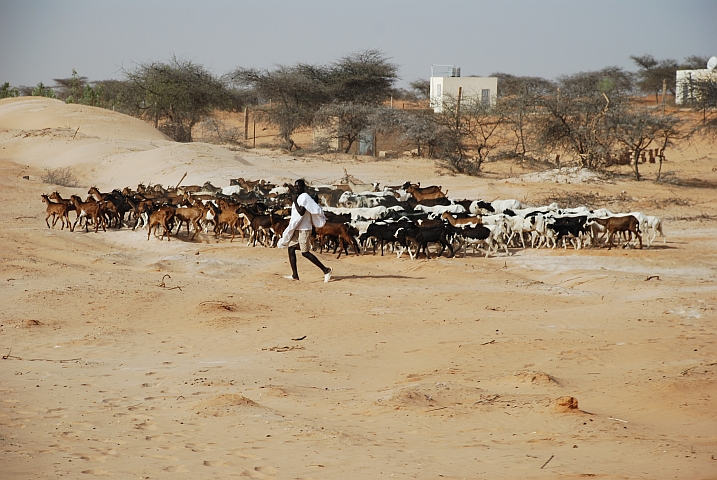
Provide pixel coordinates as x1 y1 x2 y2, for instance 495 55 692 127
124 57 232 142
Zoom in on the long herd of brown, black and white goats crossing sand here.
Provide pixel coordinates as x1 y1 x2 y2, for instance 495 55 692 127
42 177 665 258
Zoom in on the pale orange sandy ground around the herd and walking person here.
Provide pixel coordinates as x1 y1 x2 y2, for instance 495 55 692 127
0 98 717 479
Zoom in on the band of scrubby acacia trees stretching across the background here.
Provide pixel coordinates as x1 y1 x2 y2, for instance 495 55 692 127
0 50 717 179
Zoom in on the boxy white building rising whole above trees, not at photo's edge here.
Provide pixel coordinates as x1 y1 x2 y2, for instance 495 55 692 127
430 65 498 113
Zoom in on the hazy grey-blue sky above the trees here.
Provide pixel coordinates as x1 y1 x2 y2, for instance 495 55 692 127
0 0 717 86
